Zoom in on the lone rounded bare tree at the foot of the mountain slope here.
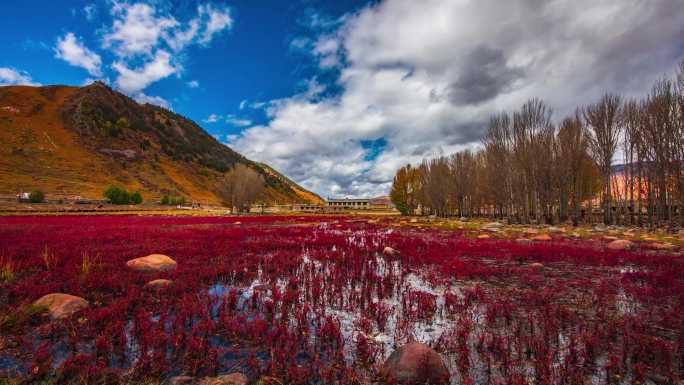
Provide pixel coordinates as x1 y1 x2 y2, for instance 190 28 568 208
218 163 266 212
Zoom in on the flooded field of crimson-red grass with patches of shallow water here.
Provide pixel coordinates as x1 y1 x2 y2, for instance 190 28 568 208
0 216 684 384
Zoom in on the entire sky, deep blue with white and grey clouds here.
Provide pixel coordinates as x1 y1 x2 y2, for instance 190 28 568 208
0 0 684 197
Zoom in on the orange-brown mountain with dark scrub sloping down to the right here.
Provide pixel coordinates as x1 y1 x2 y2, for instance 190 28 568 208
0 82 321 203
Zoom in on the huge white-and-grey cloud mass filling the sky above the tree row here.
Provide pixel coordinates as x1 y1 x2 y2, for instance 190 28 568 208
229 0 684 196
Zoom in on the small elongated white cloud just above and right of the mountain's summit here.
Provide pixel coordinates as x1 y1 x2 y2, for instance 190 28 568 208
112 50 181 94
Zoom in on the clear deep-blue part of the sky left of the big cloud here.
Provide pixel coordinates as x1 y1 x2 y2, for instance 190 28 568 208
0 0 367 136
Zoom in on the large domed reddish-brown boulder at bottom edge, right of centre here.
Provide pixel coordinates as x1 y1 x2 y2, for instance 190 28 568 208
380 342 449 385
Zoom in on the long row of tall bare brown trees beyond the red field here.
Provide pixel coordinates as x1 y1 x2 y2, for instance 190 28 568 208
390 62 684 226
